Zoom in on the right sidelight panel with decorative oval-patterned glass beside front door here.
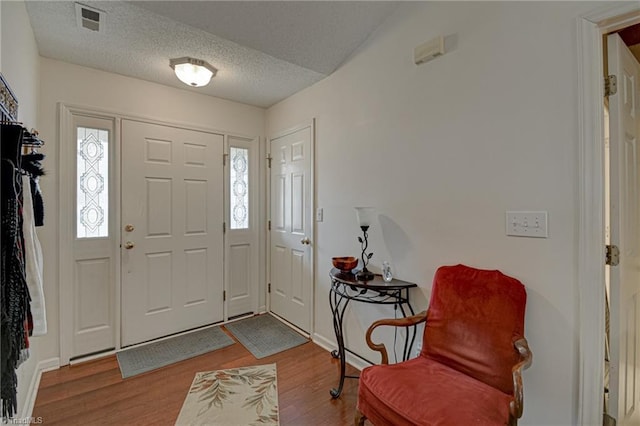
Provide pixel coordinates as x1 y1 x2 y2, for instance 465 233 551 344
225 136 260 318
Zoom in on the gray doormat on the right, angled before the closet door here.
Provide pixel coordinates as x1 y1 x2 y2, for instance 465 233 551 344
225 314 309 359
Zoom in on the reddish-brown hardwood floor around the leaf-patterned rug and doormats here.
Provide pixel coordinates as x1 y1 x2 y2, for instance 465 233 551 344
33 324 358 426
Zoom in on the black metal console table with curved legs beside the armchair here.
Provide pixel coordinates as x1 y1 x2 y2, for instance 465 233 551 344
329 268 417 398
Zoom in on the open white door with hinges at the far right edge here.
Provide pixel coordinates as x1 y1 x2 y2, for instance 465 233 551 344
607 34 640 424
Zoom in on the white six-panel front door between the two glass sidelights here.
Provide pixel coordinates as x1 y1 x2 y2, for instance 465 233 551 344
121 120 224 346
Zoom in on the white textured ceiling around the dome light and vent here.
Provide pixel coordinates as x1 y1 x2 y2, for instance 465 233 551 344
26 0 399 107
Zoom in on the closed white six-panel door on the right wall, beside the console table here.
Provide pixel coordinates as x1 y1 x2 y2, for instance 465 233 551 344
270 124 313 332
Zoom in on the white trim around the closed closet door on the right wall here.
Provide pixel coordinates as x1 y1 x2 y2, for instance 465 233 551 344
265 117 318 336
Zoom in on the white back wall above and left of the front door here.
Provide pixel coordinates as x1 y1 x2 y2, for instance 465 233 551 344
39 58 264 362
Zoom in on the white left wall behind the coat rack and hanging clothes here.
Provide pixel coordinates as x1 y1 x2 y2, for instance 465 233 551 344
0 1 45 417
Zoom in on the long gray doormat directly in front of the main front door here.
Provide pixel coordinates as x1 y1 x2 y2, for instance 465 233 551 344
116 327 234 379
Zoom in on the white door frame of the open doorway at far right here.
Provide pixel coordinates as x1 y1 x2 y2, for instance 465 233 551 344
577 3 640 425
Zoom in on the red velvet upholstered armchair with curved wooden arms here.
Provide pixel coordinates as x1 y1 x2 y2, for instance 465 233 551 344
355 265 532 426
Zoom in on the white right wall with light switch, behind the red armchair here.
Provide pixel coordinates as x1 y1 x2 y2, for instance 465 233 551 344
267 2 602 425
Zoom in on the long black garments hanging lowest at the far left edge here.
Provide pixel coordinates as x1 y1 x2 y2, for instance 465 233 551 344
0 124 30 418
